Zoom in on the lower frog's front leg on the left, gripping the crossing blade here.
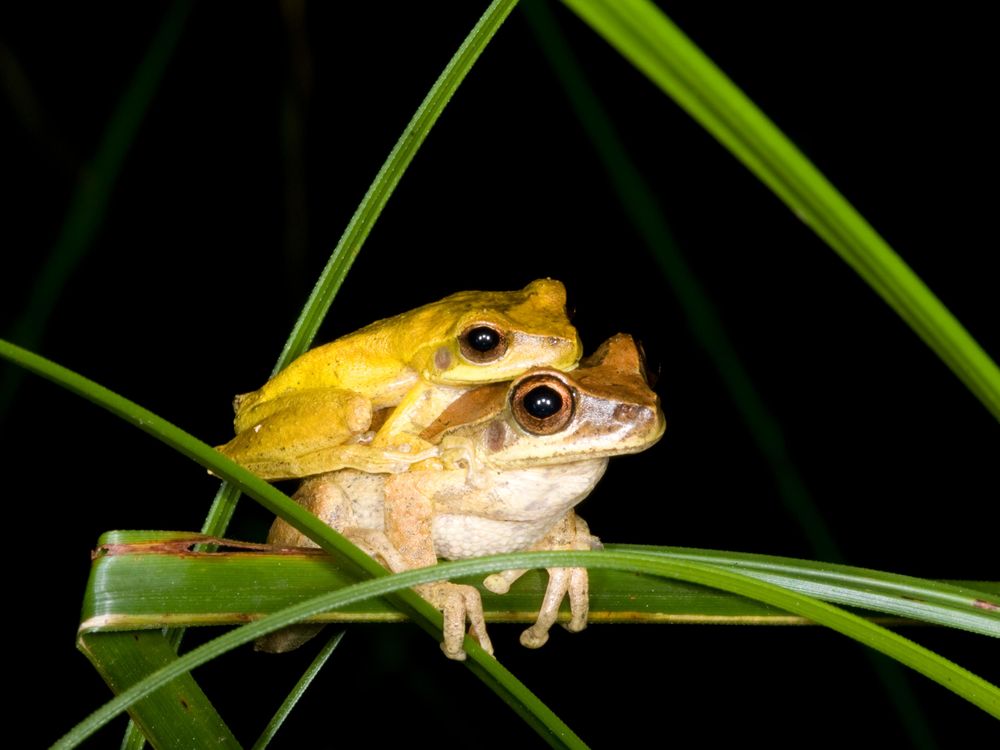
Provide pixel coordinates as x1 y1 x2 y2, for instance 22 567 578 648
385 471 493 661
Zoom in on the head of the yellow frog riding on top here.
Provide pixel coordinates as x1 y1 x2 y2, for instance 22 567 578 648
400 279 583 385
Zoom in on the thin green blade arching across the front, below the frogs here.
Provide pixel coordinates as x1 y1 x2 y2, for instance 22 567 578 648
54 551 1000 748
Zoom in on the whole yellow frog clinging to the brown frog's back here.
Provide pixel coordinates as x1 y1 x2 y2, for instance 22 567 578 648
219 279 582 480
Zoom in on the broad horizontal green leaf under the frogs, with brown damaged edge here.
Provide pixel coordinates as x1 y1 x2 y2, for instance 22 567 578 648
80 531 1000 637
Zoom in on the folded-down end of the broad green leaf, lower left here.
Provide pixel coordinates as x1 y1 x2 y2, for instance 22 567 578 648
77 630 240 749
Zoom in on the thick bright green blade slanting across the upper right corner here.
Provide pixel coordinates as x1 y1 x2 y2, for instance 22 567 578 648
564 0 1000 418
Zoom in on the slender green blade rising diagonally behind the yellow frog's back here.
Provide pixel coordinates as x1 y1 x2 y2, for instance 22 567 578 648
202 0 517 548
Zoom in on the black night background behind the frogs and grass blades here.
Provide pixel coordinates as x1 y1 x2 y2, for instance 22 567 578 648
0 2 1000 747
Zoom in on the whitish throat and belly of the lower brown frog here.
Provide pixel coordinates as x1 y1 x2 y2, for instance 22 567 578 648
431 458 608 560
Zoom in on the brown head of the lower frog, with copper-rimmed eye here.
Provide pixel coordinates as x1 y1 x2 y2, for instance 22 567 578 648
425 334 666 468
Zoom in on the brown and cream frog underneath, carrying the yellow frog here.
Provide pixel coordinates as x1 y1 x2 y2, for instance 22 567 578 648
258 334 665 659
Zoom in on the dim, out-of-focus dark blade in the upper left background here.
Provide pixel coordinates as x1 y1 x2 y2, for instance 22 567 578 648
0 0 192 424
